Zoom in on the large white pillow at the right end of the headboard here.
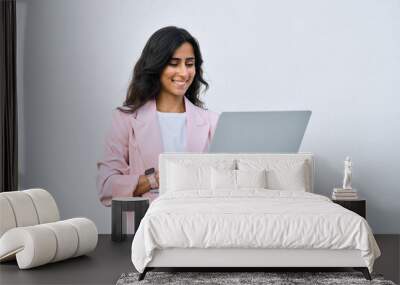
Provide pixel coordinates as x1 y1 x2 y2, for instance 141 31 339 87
238 159 311 191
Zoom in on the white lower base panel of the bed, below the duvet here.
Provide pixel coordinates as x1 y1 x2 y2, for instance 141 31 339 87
148 248 365 267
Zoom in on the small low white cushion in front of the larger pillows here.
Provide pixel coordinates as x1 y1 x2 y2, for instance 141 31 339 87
211 168 267 190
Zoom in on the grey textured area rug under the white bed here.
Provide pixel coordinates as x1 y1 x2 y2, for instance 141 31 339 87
117 271 395 285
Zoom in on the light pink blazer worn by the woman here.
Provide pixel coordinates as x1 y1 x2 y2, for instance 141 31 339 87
97 97 218 206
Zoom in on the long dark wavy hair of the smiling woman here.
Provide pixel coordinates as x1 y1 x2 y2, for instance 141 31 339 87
118 26 208 113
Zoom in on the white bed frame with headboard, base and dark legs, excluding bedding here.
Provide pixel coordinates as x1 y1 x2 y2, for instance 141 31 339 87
139 153 371 280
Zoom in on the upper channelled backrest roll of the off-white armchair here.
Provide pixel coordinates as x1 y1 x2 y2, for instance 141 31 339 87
0 189 60 237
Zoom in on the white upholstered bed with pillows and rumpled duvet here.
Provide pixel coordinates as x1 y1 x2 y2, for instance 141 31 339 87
132 153 380 279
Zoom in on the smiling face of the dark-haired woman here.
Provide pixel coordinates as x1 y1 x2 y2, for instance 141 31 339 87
160 43 196 97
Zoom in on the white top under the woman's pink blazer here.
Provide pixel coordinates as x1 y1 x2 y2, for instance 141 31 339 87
157 111 186 152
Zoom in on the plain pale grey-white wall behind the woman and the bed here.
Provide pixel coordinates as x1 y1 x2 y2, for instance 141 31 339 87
17 0 400 233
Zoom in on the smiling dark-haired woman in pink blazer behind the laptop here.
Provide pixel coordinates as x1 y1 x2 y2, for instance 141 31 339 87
97 27 218 206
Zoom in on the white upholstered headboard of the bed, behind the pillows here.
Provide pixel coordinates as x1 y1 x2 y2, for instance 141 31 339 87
159 153 314 194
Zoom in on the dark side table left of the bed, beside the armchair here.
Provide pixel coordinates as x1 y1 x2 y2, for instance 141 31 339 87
111 197 150 241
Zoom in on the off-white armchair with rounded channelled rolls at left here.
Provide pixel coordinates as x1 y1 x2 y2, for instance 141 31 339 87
0 189 98 269
